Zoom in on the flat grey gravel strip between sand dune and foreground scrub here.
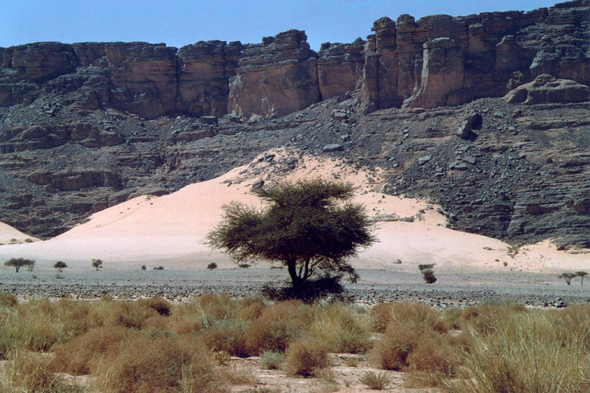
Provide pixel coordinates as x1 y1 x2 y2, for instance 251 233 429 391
0 269 590 308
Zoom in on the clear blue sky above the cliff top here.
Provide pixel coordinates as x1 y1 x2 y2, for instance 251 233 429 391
0 0 555 50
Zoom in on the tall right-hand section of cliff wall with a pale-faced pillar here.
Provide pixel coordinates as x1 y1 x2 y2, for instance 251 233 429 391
364 0 590 112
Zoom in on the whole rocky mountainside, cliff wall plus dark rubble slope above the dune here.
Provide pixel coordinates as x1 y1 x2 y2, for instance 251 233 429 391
0 0 590 248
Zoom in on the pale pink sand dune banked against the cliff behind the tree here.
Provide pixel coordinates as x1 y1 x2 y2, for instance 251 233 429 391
0 150 587 272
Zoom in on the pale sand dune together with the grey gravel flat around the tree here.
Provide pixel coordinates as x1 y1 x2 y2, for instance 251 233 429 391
0 149 590 306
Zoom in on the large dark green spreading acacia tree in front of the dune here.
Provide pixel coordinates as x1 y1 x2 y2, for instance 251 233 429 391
207 179 375 294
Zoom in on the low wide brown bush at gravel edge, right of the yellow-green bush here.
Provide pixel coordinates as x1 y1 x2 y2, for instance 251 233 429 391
369 303 451 333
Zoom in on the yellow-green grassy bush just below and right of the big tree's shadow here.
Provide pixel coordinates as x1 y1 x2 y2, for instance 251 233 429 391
309 304 372 354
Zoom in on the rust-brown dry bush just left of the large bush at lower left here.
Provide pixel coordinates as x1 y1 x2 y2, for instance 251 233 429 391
51 326 131 375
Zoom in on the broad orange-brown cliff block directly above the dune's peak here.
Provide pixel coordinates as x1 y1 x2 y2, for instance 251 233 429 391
229 30 320 120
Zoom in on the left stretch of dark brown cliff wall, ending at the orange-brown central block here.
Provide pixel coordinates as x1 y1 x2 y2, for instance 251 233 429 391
0 41 242 119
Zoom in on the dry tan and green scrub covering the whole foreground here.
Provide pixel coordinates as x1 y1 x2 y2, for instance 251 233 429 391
0 295 590 393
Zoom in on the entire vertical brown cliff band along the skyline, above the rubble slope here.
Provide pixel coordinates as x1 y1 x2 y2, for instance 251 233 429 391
0 0 590 121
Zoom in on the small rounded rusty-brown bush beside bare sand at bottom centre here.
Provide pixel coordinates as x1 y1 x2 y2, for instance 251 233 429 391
284 339 330 377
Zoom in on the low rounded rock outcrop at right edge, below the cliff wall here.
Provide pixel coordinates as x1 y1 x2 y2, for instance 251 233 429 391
504 74 590 104
